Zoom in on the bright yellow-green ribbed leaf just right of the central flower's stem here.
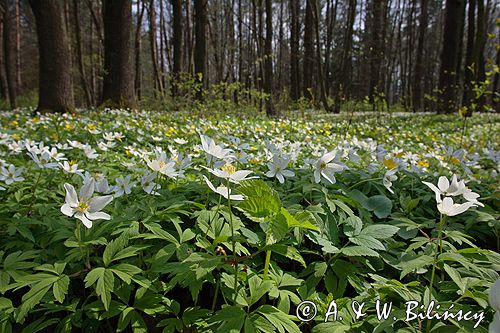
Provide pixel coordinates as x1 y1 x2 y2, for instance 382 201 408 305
237 179 281 219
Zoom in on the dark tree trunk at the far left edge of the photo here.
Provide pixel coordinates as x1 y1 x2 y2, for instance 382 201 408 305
2 0 17 109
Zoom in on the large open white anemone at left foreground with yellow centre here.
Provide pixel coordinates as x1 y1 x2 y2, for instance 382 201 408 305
61 179 113 229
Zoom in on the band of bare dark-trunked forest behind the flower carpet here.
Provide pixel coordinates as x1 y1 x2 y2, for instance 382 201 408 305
0 0 500 115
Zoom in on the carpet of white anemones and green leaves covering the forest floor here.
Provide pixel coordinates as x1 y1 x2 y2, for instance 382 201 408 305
0 110 500 333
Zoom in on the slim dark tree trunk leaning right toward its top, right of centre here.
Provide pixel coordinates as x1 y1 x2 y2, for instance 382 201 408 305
334 0 357 113
